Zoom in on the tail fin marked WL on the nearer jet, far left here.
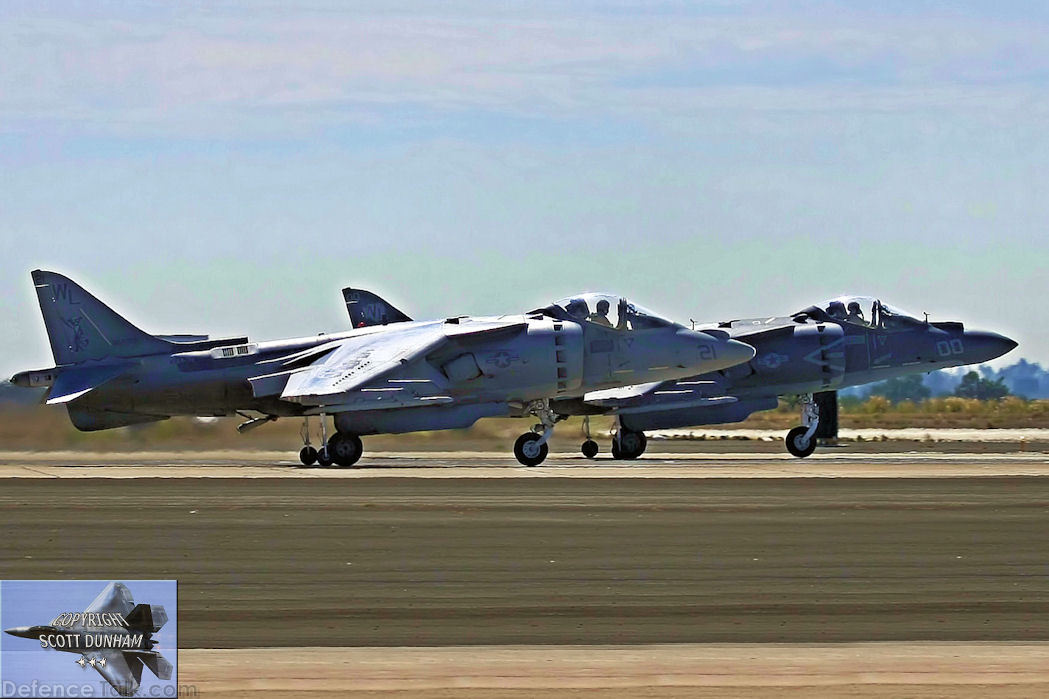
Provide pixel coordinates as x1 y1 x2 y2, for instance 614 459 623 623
33 270 172 365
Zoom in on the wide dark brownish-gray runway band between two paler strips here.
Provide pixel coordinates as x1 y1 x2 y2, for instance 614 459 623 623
0 460 1049 649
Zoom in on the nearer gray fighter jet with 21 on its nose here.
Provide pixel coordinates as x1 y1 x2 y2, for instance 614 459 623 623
12 271 754 466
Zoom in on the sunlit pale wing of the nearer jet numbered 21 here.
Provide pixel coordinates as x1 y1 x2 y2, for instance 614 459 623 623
281 319 526 412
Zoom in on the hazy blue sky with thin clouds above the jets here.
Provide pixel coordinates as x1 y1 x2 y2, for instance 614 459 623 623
0 0 1049 374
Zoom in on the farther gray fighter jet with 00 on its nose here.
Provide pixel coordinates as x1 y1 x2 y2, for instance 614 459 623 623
551 296 1016 459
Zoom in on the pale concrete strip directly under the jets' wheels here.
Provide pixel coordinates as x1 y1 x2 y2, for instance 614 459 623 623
0 448 1049 480
